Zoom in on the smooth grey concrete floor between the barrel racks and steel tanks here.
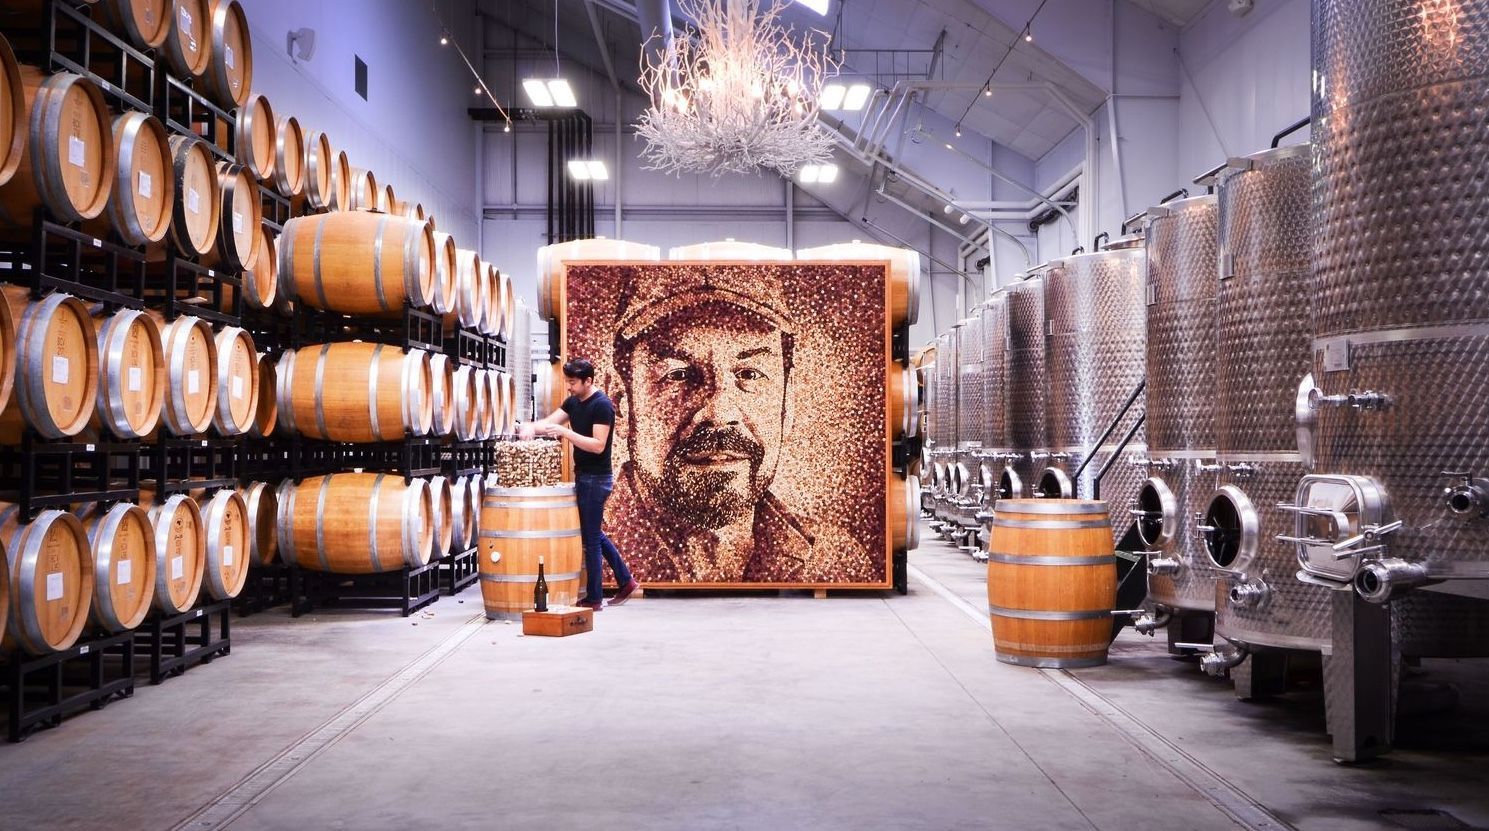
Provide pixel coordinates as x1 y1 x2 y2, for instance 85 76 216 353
0 524 1489 831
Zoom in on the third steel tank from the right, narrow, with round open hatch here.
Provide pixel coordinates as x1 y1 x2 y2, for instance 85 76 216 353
1131 191 1219 637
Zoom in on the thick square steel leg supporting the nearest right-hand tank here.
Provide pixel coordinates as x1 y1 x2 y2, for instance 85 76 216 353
1324 591 1401 762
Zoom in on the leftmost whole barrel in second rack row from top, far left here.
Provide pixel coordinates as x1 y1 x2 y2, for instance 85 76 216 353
0 66 115 226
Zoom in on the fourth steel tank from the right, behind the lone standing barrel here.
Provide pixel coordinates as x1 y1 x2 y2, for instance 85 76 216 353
1033 237 1147 541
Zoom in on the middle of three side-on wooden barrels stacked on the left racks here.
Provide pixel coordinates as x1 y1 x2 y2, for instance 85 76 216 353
278 343 433 442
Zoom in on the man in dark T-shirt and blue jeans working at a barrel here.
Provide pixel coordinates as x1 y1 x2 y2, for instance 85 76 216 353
520 357 636 612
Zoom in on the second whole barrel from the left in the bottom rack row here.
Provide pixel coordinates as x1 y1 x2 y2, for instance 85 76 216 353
76 502 155 631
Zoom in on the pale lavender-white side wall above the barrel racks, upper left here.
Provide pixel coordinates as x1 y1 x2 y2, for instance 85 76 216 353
240 0 478 240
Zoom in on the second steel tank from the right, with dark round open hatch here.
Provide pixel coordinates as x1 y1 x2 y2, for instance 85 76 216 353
1200 137 1333 698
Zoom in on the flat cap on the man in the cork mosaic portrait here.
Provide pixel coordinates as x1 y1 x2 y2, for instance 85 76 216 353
615 264 794 341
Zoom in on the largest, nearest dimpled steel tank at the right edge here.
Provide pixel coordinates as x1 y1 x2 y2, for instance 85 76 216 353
1291 0 1489 760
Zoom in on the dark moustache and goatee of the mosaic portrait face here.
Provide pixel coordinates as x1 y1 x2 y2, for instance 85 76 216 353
648 429 768 529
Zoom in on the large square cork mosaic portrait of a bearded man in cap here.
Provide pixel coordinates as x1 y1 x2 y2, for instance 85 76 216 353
563 262 890 587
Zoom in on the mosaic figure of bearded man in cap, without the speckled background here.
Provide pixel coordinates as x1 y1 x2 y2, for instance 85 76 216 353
610 268 876 582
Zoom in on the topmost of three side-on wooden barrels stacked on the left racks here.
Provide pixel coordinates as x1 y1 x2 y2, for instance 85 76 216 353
278 211 435 316
